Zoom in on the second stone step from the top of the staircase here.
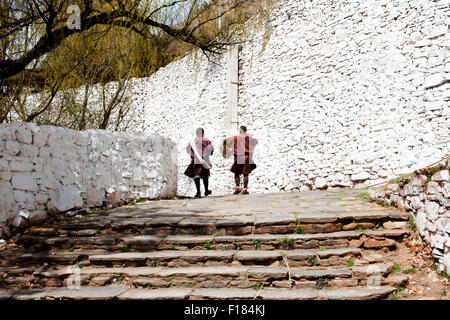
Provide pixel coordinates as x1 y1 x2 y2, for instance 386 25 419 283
17 229 410 251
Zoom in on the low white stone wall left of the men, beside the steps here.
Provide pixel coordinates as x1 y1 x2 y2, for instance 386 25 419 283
0 123 177 235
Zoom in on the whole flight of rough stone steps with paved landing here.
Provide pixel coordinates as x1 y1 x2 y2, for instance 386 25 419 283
0 190 409 300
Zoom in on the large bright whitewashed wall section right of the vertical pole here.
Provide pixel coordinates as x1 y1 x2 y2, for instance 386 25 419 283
239 0 450 190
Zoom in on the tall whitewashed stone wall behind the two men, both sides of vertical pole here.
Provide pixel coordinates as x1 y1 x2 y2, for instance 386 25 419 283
121 0 450 195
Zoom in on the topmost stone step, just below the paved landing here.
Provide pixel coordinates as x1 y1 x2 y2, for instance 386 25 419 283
22 211 405 237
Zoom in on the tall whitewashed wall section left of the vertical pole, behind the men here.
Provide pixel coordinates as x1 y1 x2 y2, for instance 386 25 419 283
125 54 233 196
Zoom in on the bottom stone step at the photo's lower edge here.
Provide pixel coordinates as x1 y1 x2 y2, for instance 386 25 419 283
0 286 395 300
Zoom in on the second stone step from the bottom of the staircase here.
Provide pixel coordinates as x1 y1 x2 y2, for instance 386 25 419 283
33 263 393 288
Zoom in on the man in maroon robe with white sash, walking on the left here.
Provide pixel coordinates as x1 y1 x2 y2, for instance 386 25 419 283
184 128 214 198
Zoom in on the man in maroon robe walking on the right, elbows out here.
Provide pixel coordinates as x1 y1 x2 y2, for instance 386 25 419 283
223 126 258 194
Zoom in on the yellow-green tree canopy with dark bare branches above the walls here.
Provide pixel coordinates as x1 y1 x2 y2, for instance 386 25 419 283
0 0 270 129
